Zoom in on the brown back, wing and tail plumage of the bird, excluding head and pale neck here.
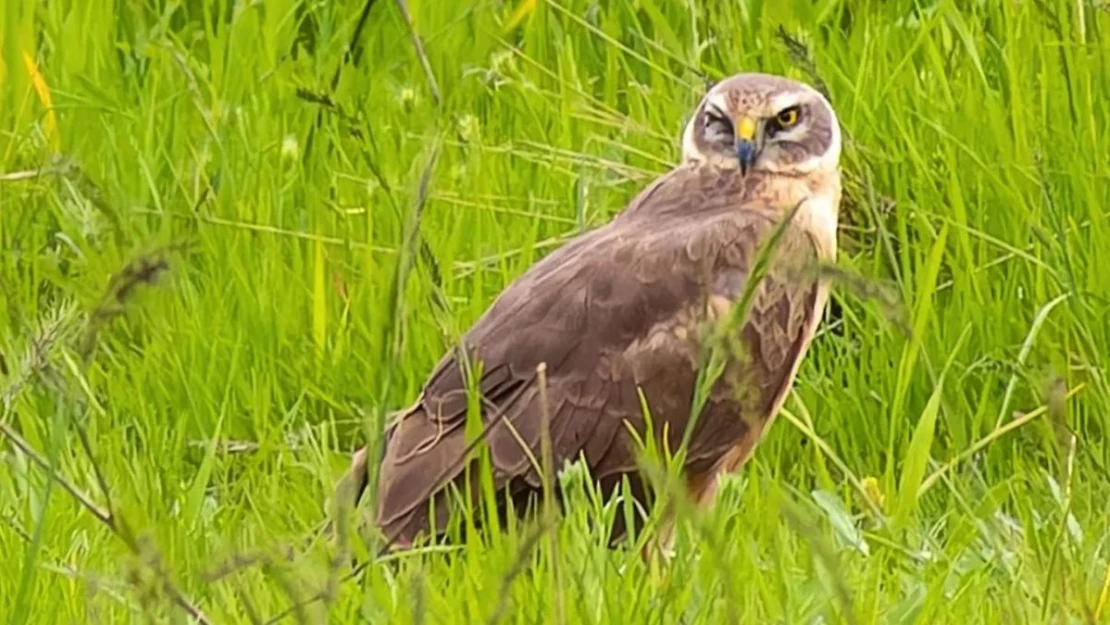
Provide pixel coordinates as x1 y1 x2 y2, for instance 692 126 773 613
356 168 815 543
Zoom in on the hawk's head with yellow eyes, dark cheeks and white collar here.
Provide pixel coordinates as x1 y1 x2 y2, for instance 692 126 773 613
683 73 840 177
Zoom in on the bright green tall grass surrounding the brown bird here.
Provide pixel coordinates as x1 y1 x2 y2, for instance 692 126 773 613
0 0 1110 625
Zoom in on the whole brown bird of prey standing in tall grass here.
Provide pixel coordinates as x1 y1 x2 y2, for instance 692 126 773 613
341 73 841 547
